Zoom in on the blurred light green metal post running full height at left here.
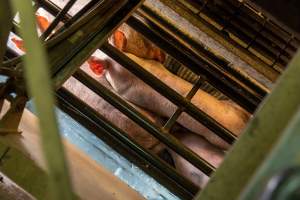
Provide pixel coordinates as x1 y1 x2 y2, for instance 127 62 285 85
11 0 74 200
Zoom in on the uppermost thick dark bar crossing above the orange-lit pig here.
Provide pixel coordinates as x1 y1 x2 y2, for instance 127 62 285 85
127 12 263 113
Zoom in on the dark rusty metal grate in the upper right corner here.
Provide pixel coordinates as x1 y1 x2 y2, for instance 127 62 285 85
171 0 300 73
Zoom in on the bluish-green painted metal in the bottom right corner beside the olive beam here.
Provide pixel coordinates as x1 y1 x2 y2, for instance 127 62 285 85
240 105 300 200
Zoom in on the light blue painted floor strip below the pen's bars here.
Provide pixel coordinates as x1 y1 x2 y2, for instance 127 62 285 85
27 102 179 200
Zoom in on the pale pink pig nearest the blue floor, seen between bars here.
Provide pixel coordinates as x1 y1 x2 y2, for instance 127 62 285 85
64 65 223 188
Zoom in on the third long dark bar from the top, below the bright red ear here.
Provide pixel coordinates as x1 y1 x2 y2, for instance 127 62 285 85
74 70 215 175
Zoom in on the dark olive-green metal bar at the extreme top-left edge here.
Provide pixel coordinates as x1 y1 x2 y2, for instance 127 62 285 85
0 0 12 67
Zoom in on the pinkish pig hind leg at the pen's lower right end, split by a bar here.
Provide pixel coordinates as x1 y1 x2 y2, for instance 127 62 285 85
169 132 224 188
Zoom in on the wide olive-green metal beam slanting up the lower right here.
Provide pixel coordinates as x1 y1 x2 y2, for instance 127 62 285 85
196 48 300 200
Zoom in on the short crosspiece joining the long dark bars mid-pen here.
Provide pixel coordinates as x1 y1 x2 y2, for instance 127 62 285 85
163 76 205 131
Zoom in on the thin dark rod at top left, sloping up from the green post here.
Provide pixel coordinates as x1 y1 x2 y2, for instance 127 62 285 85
40 0 77 40
